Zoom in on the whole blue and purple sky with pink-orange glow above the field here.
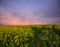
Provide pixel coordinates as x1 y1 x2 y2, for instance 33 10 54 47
0 0 60 25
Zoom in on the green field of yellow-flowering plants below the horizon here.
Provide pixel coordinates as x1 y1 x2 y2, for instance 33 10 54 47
0 25 60 47
